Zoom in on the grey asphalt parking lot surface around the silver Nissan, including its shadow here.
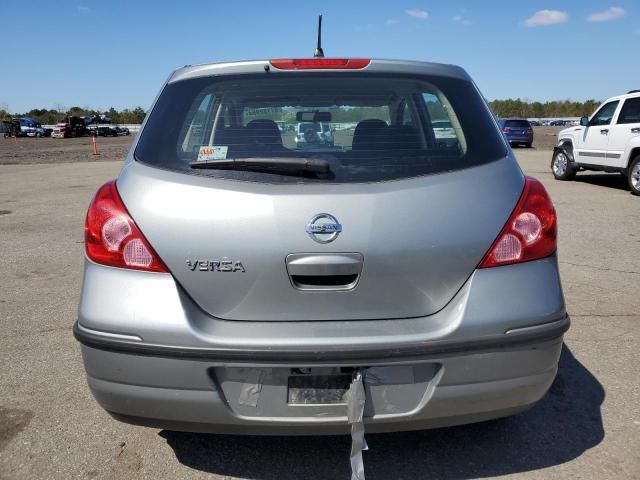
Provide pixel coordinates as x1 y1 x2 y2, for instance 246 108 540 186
0 139 640 480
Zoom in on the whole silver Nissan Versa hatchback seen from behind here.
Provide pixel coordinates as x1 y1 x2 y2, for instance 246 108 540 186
74 58 569 434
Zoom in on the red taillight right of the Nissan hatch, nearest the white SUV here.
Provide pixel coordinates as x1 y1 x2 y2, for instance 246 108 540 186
480 177 557 268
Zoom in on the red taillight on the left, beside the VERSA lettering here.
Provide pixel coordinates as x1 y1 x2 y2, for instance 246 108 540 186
84 180 169 273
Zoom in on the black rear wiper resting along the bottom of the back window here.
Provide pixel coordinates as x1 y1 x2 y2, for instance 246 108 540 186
189 157 329 173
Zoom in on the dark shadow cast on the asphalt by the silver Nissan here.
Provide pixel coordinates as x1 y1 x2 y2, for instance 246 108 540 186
160 346 605 480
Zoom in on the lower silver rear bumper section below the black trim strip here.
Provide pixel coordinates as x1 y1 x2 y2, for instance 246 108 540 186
77 337 562 435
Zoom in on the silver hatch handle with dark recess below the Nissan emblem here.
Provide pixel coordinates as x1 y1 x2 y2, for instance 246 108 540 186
286 253 364 291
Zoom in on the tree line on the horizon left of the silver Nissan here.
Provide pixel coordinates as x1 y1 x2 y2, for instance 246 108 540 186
0 105 145 125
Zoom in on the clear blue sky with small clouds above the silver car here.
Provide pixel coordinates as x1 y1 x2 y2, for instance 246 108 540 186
0 0 640 112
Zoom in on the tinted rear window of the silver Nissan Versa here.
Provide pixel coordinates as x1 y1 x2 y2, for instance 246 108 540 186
135 72 505 183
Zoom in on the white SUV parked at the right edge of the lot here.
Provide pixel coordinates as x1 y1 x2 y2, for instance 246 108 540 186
551 90 640 195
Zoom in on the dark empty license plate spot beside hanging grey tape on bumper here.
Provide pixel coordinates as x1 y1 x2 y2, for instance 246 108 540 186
287 374 353 405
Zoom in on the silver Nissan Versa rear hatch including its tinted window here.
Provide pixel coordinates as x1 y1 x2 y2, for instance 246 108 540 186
117 61 523 321
